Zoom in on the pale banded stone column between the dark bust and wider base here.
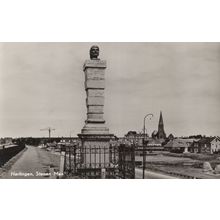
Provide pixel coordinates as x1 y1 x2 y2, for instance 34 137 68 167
82 60 109 134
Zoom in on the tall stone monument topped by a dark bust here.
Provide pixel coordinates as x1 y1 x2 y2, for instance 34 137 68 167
78 46 113 176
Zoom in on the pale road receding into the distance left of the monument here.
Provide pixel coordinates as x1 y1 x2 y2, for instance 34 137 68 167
2 146 60 179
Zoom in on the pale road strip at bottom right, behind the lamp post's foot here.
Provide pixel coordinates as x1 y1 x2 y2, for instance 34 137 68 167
135 168 177 179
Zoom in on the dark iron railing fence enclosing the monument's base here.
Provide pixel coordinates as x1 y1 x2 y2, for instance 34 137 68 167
63 144 135 179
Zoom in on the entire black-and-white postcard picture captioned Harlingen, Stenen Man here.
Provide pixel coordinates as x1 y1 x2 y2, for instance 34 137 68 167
0 42 220 179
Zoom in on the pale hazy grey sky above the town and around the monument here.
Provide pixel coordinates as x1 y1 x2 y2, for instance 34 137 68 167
0 43 220 137
